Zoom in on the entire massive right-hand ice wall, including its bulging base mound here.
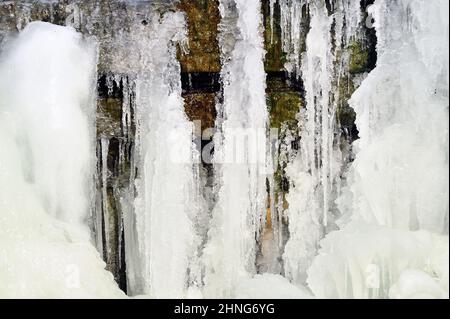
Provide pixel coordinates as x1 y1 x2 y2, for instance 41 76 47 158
308 0 449 298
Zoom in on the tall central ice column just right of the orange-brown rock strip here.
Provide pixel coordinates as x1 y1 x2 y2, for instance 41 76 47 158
204 0 268 298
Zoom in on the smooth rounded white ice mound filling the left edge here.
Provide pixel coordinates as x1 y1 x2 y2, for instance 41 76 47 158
0 22 123 298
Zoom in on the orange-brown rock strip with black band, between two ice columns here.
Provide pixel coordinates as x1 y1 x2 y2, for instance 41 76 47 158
177 0 222 162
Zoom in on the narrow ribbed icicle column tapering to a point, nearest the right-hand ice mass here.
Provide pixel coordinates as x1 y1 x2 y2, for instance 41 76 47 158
284 2 350 283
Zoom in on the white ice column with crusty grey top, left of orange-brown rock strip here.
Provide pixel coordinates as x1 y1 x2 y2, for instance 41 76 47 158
119 13 201 298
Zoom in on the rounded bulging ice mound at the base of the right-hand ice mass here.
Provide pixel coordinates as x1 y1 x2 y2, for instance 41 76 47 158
308 222 449 299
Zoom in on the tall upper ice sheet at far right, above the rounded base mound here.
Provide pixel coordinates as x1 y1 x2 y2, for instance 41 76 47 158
343 1 449 233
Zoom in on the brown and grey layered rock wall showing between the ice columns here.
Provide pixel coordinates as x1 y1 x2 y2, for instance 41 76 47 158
0 0 376 291
